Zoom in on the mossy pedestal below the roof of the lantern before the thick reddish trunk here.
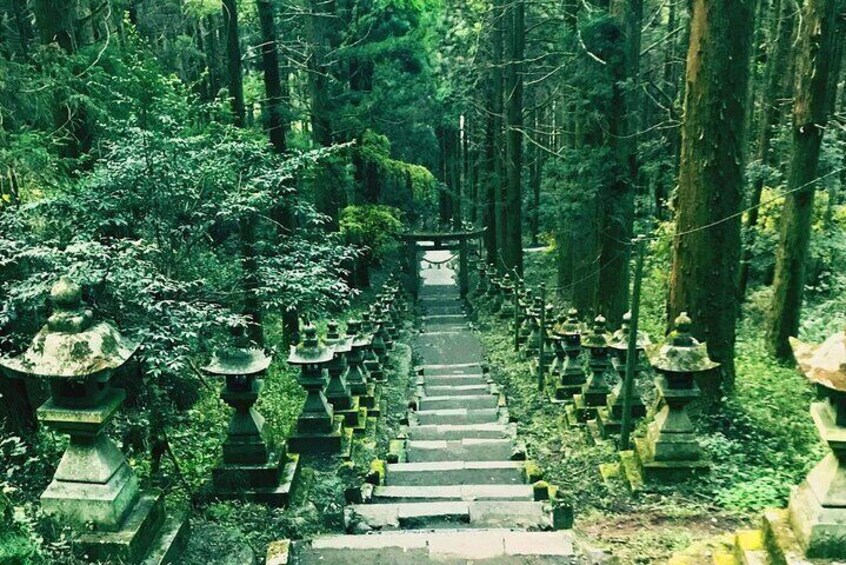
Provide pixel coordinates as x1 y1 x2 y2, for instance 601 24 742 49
634 376 710 482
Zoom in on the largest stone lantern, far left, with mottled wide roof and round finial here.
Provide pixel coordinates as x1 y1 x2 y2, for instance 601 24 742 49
0 277 187 563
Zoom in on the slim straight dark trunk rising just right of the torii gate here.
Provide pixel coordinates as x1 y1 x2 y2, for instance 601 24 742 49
503 0 526 275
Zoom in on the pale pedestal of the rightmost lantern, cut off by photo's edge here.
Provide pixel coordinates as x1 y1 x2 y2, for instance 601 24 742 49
788 402 846 559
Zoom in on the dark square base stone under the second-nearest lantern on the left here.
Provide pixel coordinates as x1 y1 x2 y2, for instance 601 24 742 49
213 453 300 508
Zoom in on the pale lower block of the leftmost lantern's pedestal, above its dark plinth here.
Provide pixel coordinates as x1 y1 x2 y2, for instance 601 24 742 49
41 462 138 530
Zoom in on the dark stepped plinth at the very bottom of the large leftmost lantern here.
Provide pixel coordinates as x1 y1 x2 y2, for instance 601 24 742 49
74 492 189 565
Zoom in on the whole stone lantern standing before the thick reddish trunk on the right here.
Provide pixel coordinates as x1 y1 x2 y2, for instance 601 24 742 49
634 312 720 482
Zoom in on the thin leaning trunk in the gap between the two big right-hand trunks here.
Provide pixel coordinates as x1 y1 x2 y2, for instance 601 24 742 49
739 0 795 301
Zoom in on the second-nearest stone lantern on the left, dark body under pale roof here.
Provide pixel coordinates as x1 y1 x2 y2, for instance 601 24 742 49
202 348 299 506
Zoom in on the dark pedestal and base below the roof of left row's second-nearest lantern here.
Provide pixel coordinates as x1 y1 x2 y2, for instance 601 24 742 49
212 380 299 507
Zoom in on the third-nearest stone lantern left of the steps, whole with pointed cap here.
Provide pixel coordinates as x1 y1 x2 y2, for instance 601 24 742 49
288 324 344 453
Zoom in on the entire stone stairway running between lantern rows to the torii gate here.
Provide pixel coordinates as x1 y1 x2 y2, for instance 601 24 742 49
290 251 576 564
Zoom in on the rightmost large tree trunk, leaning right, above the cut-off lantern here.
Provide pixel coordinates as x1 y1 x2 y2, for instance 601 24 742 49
767 0 837 360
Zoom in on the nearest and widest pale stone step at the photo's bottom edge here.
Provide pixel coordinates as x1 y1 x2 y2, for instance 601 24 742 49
288 529 576 565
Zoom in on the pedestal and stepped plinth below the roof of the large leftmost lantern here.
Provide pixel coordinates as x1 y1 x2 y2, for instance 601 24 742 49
38 389 188 563
